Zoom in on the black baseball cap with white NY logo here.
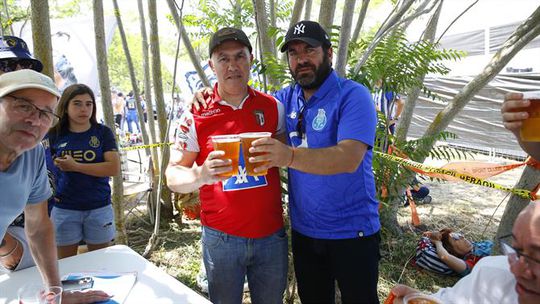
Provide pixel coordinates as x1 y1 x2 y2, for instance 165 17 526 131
281 20 332 52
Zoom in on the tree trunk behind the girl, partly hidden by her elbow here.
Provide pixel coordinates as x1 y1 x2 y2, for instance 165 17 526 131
94 0 127 244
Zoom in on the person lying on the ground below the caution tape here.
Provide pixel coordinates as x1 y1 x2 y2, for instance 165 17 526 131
416 228 493 276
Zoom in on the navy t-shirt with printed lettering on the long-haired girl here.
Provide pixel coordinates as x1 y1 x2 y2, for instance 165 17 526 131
49 124 118 210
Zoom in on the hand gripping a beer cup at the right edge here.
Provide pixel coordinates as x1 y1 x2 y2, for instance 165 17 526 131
501 93 531 136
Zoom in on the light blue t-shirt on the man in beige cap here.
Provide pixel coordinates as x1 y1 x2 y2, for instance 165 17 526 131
0 145 51 239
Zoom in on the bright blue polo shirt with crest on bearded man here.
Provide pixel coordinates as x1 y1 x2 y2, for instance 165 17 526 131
275 71 381 239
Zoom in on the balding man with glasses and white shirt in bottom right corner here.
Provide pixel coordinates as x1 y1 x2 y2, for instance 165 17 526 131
392 202 540 304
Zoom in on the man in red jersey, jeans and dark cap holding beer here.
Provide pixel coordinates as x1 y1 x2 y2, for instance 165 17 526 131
166 28 288 303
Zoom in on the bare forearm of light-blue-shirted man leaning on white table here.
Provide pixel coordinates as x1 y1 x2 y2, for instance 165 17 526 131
25 218 60 286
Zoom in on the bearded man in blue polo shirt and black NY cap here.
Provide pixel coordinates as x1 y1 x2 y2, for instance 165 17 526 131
250 21 380 303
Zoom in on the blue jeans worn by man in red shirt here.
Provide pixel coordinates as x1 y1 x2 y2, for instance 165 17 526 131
202 226 288 304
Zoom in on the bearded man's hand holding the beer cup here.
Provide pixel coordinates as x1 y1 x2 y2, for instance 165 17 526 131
247 137 294 172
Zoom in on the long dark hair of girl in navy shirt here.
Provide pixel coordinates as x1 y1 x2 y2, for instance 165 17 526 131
49 83 98 136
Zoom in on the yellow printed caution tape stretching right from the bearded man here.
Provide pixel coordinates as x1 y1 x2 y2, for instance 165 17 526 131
374 151 536 200
